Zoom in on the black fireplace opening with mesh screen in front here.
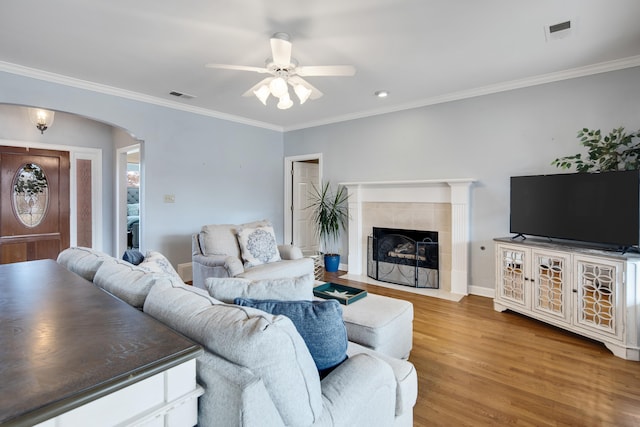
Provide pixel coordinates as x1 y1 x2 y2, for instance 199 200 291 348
367 227 440 289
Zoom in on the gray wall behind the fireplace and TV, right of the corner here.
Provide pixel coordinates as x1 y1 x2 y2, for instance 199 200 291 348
284 68 640 291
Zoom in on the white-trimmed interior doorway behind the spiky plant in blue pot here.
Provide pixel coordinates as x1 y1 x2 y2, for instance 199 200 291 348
284 154 322 253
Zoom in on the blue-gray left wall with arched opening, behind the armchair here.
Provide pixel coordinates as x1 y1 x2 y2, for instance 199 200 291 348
0 72 284 266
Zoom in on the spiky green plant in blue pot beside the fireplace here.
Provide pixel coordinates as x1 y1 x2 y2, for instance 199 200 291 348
309 182 349 272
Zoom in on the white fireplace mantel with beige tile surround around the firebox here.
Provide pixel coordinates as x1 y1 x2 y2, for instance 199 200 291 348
342 179 474 295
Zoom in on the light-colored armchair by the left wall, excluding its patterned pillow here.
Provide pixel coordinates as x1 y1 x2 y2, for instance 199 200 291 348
191 221 314 289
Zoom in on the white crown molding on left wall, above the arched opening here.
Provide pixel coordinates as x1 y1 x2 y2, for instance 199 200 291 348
0 61 284 132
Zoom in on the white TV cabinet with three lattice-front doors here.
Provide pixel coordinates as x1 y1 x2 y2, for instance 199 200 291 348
493 238 640 361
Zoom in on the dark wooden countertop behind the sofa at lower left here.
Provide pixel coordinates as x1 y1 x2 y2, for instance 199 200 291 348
0 260 202 425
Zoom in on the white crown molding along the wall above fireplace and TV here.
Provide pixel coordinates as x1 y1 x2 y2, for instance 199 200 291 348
284 55 640 132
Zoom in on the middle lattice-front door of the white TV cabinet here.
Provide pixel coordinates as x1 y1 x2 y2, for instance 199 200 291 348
531 251 571 321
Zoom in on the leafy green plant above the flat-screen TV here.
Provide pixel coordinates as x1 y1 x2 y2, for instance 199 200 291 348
551 127 640 172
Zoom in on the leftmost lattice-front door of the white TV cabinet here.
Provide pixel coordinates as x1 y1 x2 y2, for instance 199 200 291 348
496 245 531 308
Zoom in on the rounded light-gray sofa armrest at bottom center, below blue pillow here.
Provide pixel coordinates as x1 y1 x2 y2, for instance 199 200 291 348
321 354 396 427
